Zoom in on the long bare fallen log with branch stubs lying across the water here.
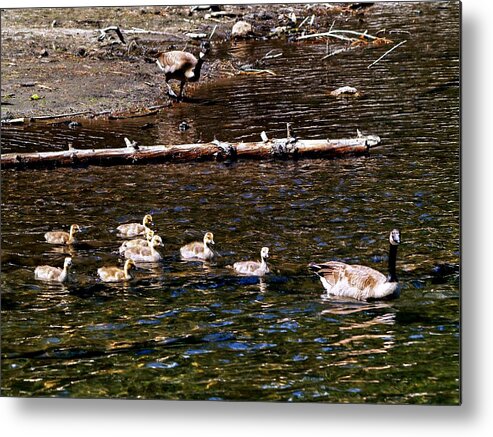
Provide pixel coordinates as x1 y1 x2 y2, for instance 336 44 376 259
0 135 380 169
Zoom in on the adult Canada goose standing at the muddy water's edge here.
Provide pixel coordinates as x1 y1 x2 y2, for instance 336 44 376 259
156 41 210 100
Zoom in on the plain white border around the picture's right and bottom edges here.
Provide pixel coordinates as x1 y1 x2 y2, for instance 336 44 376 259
0 0 493 437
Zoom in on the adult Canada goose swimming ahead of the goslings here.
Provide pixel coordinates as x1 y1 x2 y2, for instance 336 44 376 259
309 229 401 300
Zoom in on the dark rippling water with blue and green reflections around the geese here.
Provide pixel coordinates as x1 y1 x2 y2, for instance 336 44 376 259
1 3 460 404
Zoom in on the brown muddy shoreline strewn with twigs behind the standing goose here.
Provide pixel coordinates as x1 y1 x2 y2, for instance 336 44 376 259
1 4 364 120
